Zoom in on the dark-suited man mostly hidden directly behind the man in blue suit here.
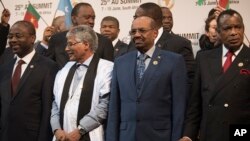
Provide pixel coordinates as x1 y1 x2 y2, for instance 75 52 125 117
129 2 194 85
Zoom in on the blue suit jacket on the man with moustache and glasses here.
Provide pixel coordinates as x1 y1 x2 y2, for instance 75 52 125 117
106 48 187 141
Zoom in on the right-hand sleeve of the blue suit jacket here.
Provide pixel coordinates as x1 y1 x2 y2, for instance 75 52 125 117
171 57 187 141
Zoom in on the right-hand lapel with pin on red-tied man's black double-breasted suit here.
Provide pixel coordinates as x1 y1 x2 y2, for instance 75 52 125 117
211 45 249 100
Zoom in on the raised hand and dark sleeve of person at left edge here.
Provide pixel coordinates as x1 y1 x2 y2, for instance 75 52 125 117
0 9 10 56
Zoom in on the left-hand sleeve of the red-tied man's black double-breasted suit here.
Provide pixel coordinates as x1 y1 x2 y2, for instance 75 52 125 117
183 54 202 140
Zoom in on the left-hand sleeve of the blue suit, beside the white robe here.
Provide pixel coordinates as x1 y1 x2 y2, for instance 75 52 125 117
106 63 120 141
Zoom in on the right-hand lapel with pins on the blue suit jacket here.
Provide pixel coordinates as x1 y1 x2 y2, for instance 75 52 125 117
138 48 161 97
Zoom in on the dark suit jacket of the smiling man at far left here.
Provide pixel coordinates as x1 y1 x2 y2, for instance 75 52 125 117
0 54 58 141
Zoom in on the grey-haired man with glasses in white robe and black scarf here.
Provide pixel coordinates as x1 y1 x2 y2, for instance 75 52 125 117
51 25 113 141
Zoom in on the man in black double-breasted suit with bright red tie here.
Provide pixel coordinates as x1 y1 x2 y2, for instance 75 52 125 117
181 9 250 141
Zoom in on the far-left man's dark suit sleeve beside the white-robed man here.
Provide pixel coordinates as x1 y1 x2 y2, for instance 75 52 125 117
38 63 58 141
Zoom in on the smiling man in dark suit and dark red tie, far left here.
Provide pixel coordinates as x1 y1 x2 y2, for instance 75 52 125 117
0 21 58 141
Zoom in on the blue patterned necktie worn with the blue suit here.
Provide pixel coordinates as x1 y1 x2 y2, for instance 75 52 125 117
137 54 147 82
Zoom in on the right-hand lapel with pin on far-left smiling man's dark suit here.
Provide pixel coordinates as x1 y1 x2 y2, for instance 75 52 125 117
12 53 39 100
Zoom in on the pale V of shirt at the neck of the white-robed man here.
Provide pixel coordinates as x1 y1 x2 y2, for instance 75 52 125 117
72 64 88 96
